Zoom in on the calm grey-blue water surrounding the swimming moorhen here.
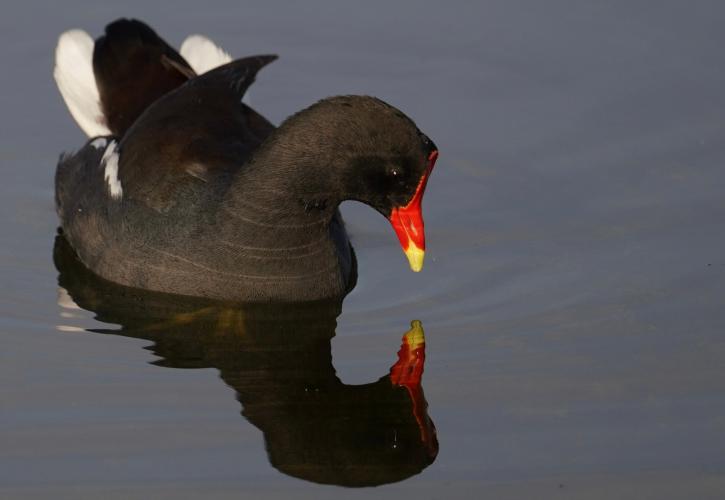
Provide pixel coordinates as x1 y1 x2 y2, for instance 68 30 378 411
0 1 725 498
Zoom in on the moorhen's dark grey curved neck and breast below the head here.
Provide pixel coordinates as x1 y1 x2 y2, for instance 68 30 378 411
199 107 356 300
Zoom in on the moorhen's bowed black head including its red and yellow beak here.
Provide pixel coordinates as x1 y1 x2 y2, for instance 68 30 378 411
279 96 438 271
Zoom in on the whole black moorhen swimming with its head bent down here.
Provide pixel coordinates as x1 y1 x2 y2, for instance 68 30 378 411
55 19 438 301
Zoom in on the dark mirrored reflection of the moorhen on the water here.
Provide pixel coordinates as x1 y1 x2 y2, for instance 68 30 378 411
54 236 438 486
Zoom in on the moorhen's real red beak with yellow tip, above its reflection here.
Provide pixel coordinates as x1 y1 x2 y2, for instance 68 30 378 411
389 150 438 272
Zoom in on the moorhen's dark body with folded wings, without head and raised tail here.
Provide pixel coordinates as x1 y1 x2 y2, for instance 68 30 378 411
56 58 356 301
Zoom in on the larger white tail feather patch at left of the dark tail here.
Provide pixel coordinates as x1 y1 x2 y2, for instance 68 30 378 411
53 30 111 137
